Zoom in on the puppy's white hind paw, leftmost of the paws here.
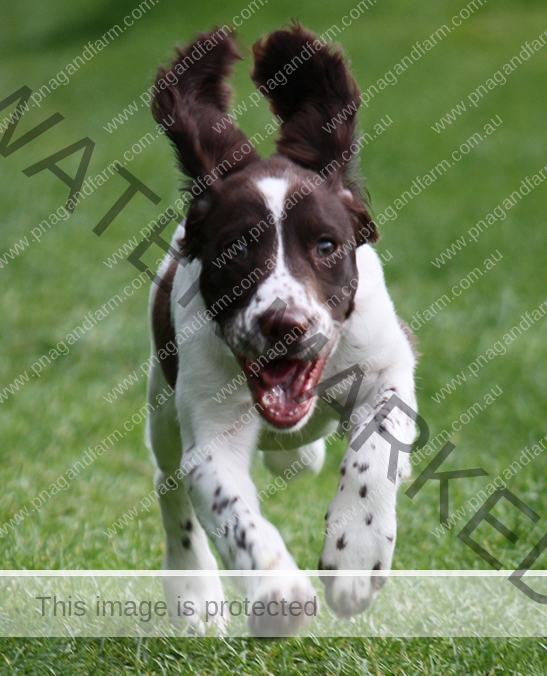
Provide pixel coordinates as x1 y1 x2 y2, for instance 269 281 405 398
162 576 227 636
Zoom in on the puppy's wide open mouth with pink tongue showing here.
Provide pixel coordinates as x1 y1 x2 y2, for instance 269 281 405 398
240 355 327 428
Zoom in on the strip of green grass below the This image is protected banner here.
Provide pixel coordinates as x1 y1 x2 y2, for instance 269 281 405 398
0 638 547 676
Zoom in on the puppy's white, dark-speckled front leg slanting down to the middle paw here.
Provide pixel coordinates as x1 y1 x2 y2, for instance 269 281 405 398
182 425 317 636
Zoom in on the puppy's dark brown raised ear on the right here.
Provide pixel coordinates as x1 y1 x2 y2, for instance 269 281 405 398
251 24 378 244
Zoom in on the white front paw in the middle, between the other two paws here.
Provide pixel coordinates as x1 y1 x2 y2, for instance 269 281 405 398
248 577 319 638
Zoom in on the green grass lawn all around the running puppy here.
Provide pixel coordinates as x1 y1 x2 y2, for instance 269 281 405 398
0 0 547 675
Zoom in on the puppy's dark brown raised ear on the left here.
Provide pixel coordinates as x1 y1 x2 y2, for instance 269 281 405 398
152 29 259 258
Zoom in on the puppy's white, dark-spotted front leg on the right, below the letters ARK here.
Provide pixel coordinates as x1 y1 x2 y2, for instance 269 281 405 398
319 392 415 617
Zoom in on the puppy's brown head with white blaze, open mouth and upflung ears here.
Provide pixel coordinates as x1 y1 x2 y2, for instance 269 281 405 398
153 25 377 430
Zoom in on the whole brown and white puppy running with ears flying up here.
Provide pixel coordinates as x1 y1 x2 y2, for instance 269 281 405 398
148 25 416 635
